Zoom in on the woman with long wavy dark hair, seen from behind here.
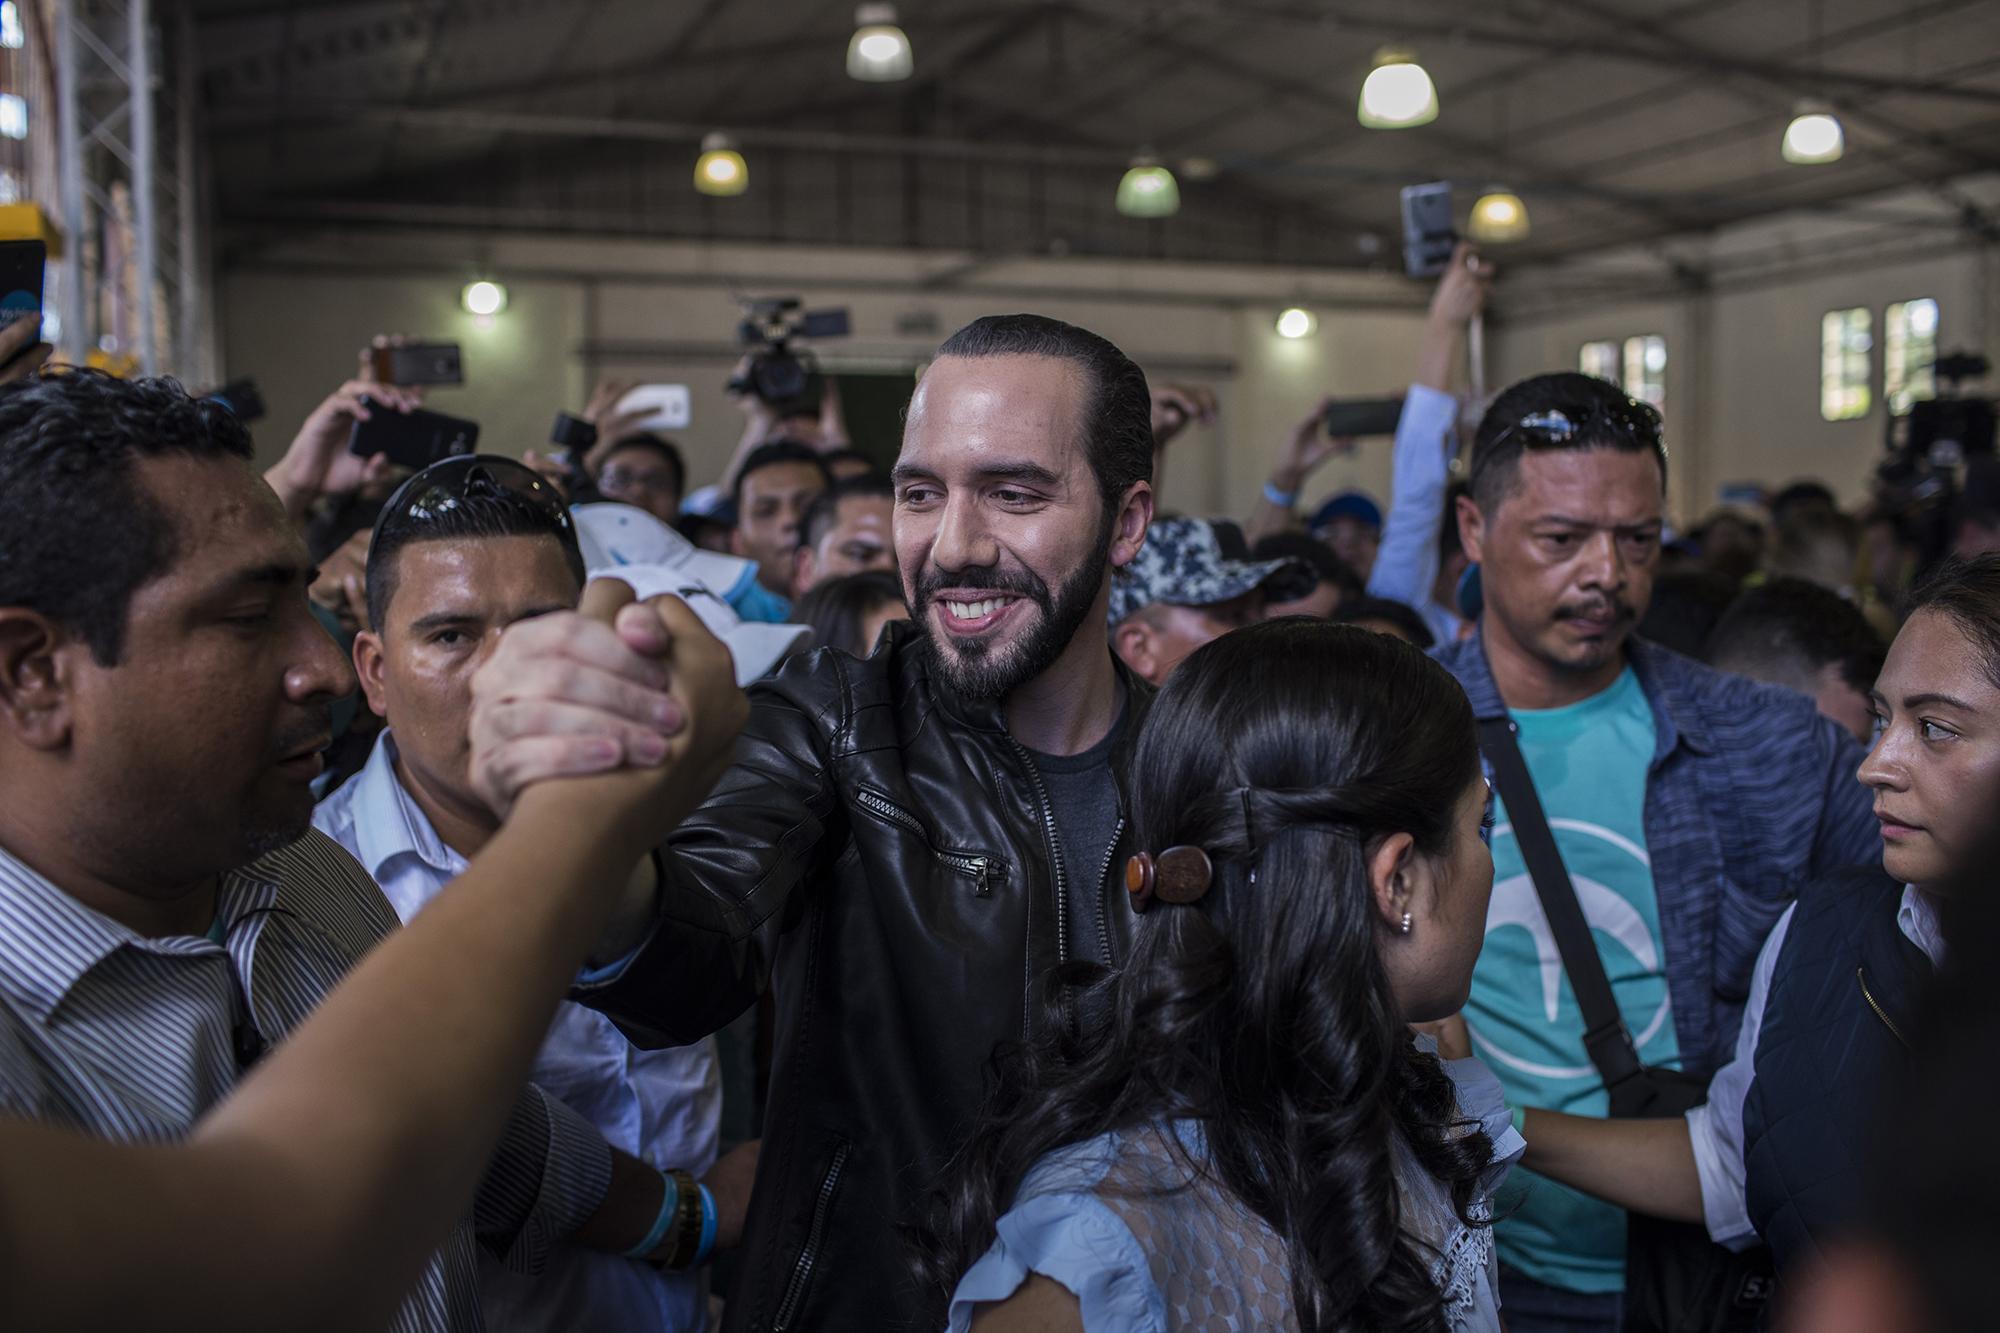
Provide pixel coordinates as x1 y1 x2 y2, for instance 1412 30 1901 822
922 618 1522 1333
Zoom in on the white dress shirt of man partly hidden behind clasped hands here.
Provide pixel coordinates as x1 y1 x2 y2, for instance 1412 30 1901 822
324 731 722 1333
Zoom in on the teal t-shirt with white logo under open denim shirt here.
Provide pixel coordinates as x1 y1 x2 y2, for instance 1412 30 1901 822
1466 669 1680 1291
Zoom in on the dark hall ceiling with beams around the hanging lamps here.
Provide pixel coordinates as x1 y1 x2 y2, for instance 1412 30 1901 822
194 0 2000 266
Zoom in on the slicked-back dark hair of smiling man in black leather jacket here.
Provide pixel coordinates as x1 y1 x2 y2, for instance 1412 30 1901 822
938 314 1152 514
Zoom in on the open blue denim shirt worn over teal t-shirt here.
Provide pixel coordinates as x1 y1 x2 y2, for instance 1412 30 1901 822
1434 634 1882 1077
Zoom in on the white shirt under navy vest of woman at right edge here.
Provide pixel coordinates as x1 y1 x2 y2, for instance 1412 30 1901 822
1688 885 1944 1249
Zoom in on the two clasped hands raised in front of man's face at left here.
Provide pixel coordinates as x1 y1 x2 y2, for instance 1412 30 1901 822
472 578 750 853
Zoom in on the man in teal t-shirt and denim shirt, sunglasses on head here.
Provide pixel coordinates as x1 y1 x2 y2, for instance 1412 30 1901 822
1438 372 1876 1333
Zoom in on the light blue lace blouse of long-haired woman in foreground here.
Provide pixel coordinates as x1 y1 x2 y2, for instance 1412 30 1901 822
948 1037 1526 1333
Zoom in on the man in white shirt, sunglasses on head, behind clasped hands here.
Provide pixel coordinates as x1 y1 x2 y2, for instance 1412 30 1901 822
312 456 754 1331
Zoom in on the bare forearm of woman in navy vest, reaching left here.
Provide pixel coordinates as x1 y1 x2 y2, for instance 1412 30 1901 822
1520 1111 1702 1223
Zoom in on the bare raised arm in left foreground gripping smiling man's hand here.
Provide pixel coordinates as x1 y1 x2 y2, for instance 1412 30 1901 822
0 584 744 1331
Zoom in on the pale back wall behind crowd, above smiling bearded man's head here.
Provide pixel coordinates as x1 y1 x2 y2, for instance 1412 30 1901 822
220 232 1426 514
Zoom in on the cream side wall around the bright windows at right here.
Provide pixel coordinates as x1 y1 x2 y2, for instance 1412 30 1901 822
1490 178 2000 522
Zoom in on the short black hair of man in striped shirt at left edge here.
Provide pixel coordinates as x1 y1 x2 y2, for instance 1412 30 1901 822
0 370 252 667
